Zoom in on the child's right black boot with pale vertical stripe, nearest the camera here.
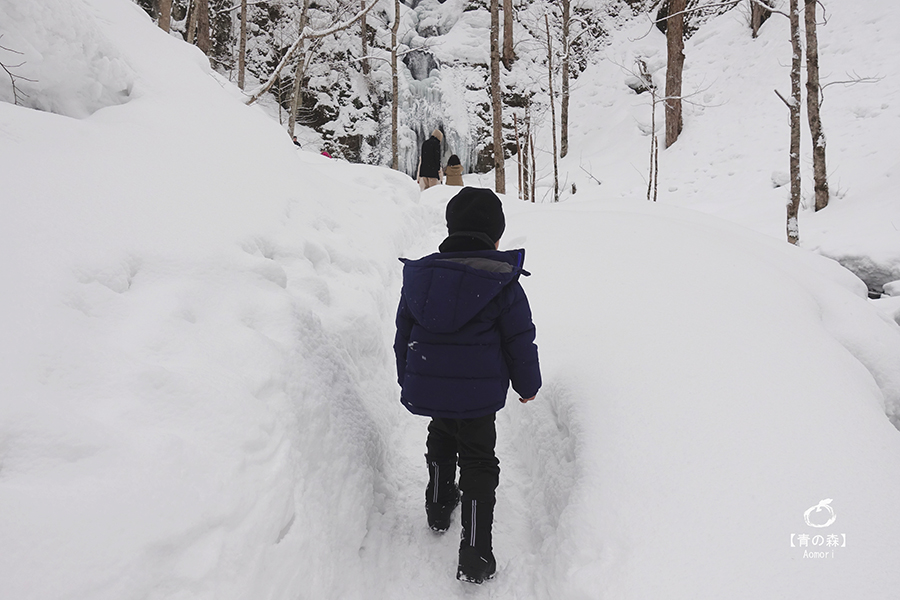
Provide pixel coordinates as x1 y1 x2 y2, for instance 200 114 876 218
456 497 497 583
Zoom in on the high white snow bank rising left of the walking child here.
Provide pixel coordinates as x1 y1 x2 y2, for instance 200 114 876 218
0 0 417 598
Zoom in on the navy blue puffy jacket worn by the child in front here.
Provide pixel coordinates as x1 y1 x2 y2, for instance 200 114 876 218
394 250 541 419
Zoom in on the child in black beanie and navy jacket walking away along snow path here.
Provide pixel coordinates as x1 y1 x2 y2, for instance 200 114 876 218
394 187 541 583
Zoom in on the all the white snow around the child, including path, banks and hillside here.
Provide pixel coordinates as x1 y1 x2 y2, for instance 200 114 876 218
0 0 900 600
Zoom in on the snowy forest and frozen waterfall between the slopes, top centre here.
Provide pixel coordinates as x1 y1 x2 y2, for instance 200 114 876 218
125 0 624 174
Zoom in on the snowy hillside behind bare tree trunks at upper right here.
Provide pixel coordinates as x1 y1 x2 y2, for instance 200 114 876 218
543 0 900 298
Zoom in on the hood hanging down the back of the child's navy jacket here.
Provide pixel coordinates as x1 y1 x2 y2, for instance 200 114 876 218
400 249 530 333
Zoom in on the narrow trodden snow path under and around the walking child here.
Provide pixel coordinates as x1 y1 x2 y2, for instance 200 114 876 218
316 188 577 598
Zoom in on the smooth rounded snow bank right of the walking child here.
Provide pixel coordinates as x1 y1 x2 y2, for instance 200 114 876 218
498 195 900 598
